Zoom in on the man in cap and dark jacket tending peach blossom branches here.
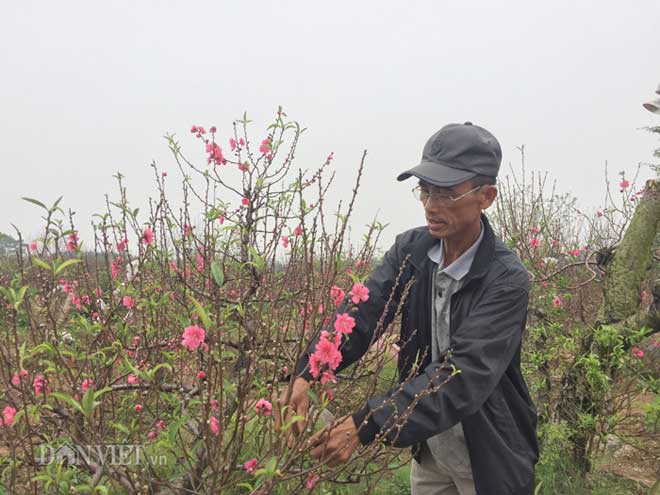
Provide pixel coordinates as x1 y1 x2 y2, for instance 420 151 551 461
280 122 538 495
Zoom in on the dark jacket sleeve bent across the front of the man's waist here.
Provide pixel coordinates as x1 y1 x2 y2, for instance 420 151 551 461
353 282 528 447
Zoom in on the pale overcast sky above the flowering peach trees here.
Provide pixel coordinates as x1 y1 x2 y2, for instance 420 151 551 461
0 0 660 252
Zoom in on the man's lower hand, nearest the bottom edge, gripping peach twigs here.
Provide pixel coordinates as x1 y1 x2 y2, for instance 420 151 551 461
307 416 360 466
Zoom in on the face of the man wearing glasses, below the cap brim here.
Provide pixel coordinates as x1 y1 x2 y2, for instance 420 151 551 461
419 180 497 239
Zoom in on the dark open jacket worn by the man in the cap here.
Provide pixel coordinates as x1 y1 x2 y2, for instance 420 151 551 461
298 215 538 495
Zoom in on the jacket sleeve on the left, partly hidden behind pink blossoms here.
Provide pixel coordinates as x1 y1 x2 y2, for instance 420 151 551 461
296 232 408 381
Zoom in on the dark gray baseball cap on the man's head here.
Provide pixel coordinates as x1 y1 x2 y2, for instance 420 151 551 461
397 122 502 187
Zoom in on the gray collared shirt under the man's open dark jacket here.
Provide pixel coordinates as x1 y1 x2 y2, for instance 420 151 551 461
427 224 484 476
